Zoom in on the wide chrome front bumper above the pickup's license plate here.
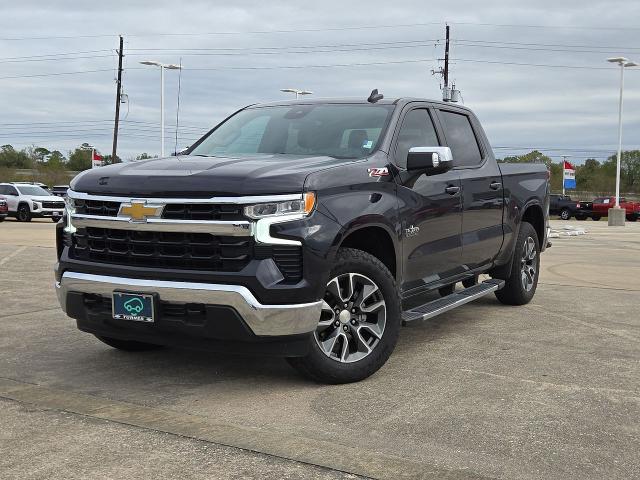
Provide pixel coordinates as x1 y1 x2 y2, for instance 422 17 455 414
56 272 322 336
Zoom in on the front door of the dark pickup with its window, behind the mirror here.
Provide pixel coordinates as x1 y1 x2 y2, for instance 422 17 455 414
393 104 462 292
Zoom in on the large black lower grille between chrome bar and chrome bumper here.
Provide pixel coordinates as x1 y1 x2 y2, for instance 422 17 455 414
70 227 253 272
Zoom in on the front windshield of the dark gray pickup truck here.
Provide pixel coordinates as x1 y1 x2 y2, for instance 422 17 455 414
190 104 394 158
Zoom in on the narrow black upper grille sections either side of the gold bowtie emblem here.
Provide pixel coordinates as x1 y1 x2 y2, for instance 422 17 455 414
73 199 245 221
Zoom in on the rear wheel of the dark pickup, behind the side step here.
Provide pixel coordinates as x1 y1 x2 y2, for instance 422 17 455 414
495 222 540 305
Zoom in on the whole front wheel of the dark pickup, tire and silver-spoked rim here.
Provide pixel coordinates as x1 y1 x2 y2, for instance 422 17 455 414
287 248 401 384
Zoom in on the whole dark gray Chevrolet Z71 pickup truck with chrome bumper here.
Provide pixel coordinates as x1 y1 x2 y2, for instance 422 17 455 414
55 92 549 383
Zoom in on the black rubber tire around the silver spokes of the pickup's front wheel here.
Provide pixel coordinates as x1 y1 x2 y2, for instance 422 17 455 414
287 248 401 384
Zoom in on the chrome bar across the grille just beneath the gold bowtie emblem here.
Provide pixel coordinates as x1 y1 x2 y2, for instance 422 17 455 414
71 213 253 237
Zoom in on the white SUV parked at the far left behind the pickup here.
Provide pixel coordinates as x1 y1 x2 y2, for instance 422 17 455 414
0 183 64 222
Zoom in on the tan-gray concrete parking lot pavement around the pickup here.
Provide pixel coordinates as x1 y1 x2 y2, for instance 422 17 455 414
0 221 640 479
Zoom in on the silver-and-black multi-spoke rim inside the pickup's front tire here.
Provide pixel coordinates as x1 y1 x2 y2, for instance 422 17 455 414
314 273 387 363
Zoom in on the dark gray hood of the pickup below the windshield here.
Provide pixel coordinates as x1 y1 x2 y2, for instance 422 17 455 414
71 155 352 198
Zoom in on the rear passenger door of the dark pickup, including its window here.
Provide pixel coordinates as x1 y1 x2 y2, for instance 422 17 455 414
438 107 504 269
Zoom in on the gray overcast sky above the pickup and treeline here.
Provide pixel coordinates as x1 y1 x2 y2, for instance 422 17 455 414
0 0 640 163
